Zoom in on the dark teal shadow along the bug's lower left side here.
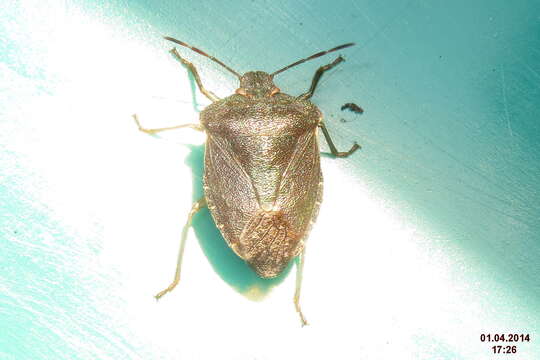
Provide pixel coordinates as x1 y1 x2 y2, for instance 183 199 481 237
181 145 293 300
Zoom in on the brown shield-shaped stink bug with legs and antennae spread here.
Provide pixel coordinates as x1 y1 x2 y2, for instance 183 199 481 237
134 37 360 325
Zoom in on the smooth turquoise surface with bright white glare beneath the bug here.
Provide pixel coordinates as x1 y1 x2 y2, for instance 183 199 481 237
0 0 540 360
